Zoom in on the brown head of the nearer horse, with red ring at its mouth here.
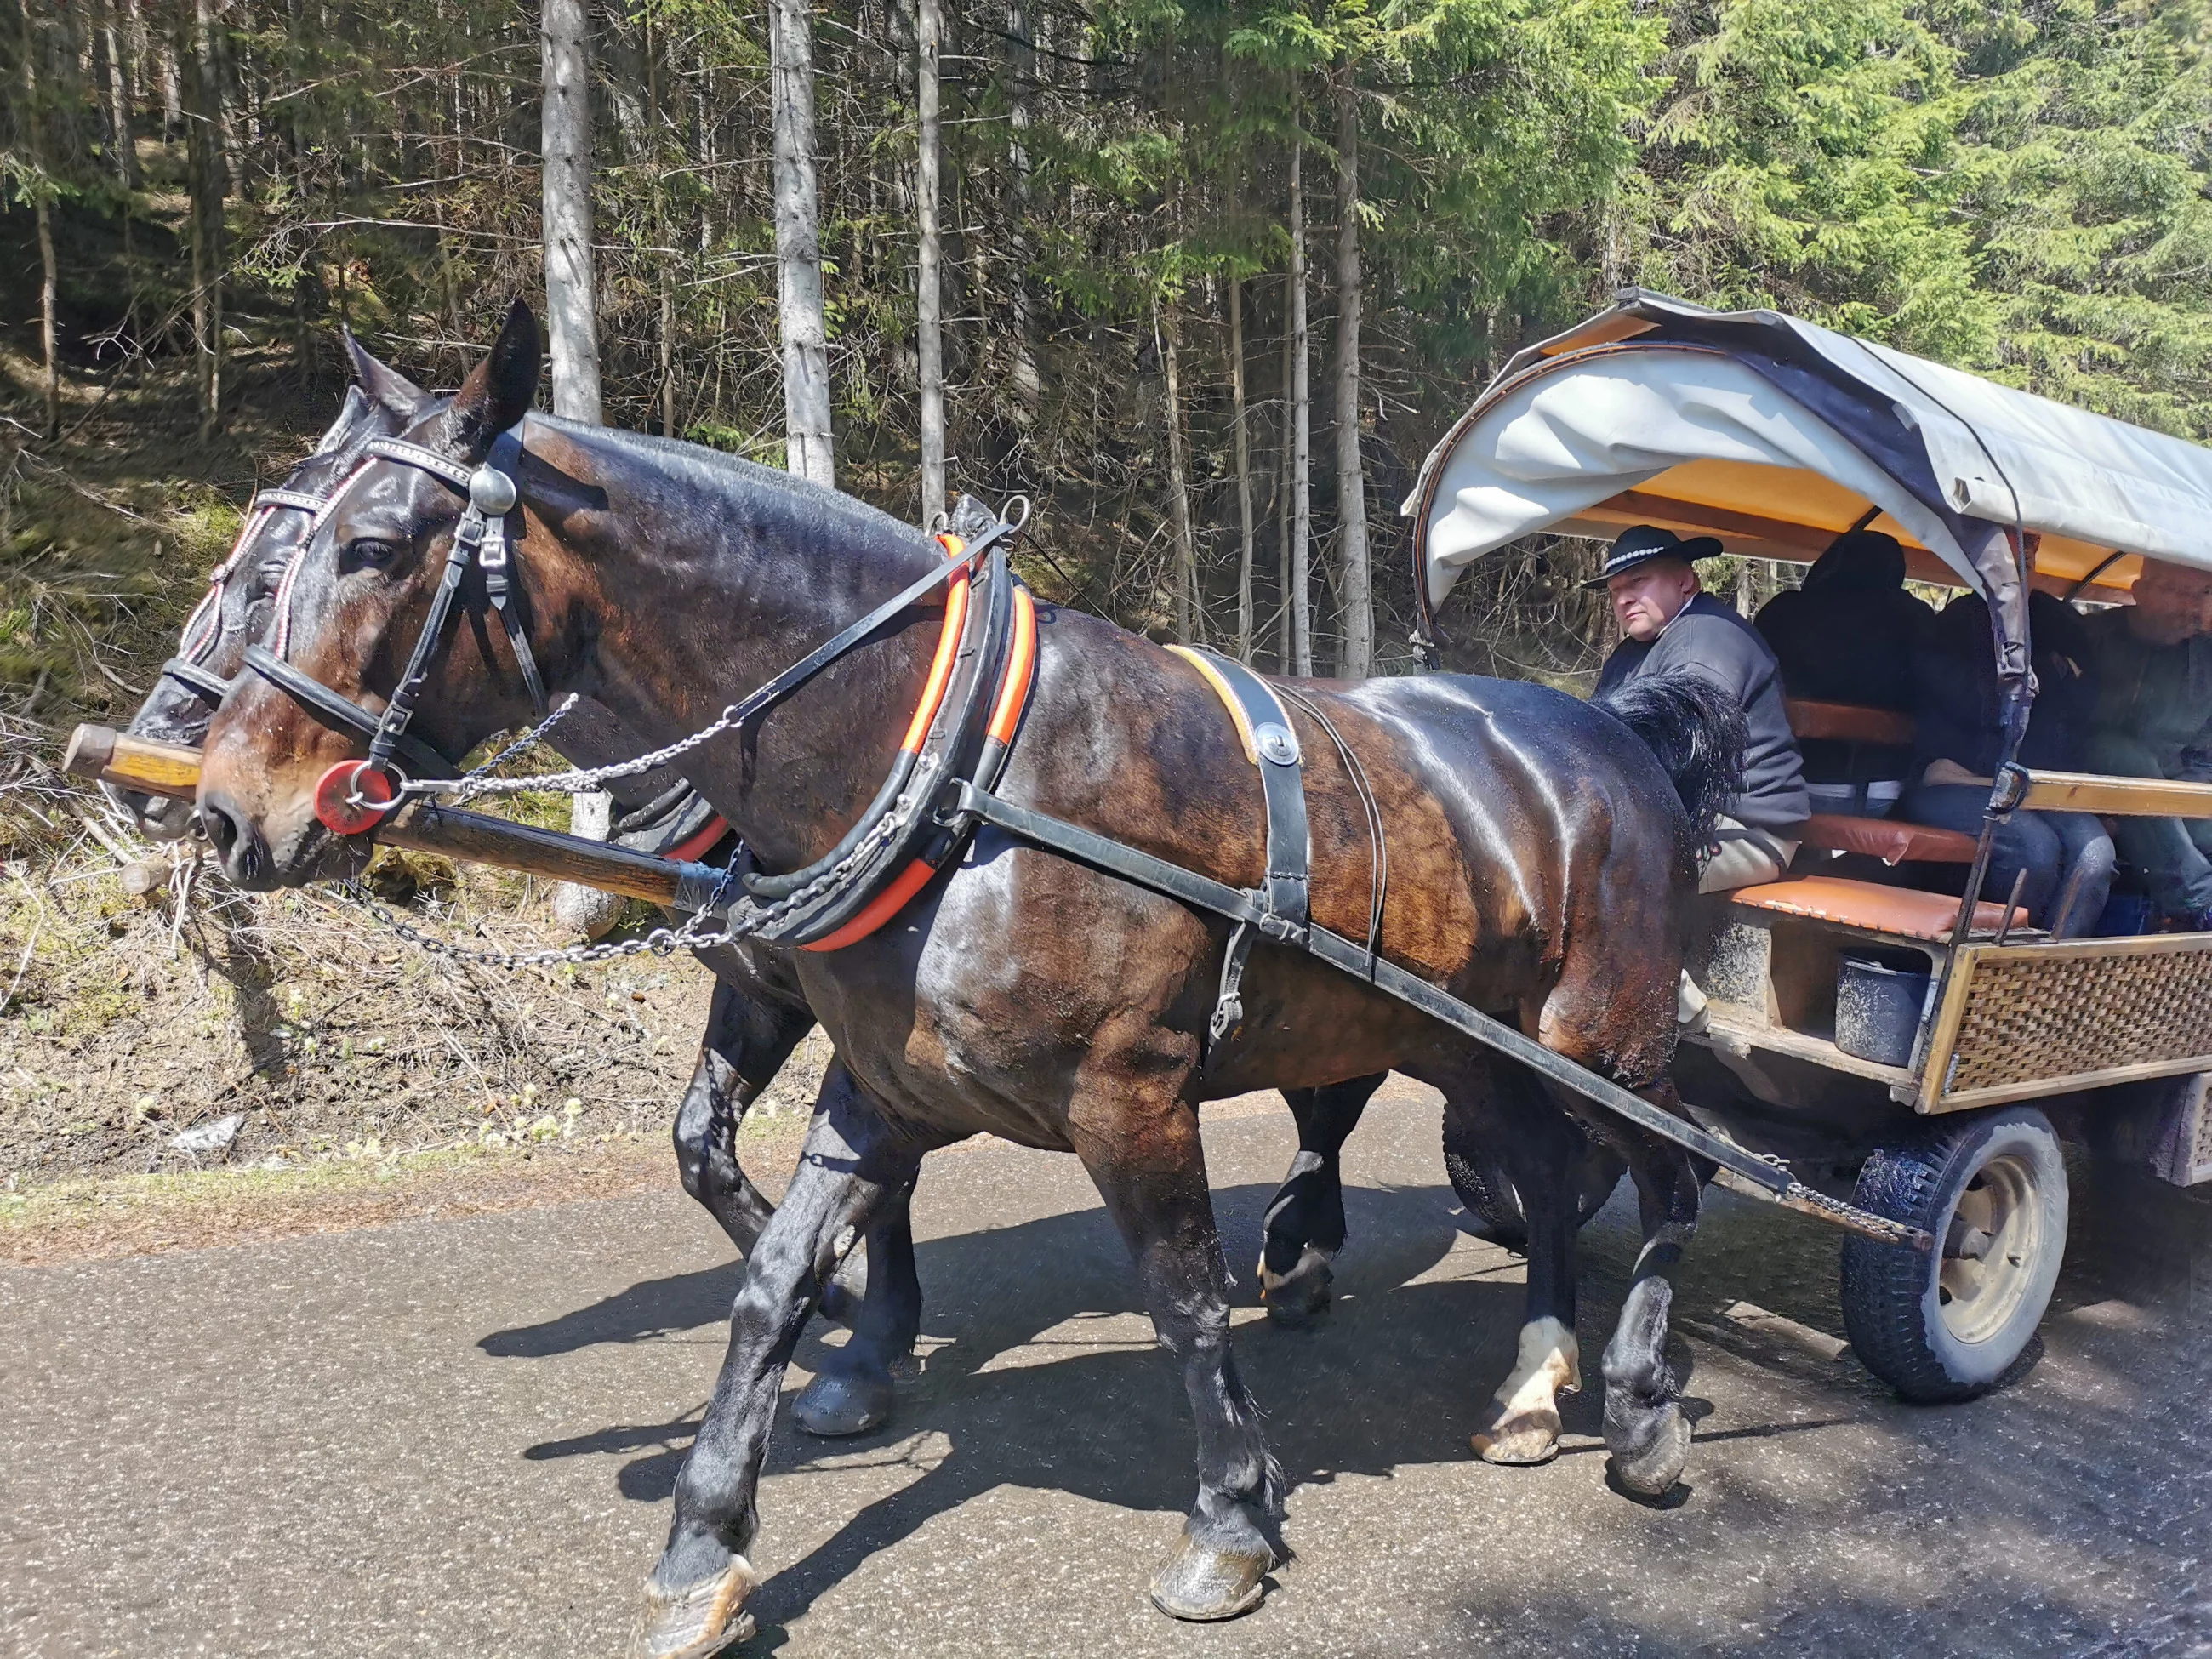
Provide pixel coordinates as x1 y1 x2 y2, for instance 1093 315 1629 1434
199 303 575 887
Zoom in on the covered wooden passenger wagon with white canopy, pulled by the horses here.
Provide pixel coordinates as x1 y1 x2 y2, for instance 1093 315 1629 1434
1405 290 2212 1400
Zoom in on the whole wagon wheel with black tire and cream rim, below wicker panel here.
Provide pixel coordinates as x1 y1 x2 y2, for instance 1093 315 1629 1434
1843 1106 2066 1405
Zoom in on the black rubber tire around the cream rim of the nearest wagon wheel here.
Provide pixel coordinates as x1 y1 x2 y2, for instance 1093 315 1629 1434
1843 1106 2066 1405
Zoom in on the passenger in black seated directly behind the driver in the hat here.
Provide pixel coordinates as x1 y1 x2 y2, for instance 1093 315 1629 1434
1754 531 1936 816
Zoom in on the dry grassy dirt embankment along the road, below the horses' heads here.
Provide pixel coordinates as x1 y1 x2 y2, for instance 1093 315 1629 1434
0 805 827 1261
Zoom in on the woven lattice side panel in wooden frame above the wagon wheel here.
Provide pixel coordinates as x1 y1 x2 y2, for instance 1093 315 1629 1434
1942 951 2212 1095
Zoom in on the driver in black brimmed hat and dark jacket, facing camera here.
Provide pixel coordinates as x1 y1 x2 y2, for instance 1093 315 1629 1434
1588 524 1811 893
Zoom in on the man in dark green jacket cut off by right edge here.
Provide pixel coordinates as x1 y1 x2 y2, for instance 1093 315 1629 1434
2084 560 2212 929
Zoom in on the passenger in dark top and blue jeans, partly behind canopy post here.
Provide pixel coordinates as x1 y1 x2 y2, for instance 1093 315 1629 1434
1898 593 2112 938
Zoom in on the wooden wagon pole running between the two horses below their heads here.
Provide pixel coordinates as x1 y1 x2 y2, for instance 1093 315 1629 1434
62 726 699 904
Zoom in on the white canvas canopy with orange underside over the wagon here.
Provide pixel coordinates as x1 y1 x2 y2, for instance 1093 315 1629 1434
1405 290 2212 677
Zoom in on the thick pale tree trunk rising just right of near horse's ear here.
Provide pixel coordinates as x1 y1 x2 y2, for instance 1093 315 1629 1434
539 0 601 425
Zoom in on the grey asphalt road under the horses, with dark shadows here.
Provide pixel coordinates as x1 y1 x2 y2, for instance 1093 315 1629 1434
0 1086 2212 1659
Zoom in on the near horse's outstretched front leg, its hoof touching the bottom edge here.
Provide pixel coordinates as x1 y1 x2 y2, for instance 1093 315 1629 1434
641 1064 926 1659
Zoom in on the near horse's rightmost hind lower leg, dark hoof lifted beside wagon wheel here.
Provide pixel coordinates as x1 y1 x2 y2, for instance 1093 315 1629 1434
1604 1081 1699 1497
